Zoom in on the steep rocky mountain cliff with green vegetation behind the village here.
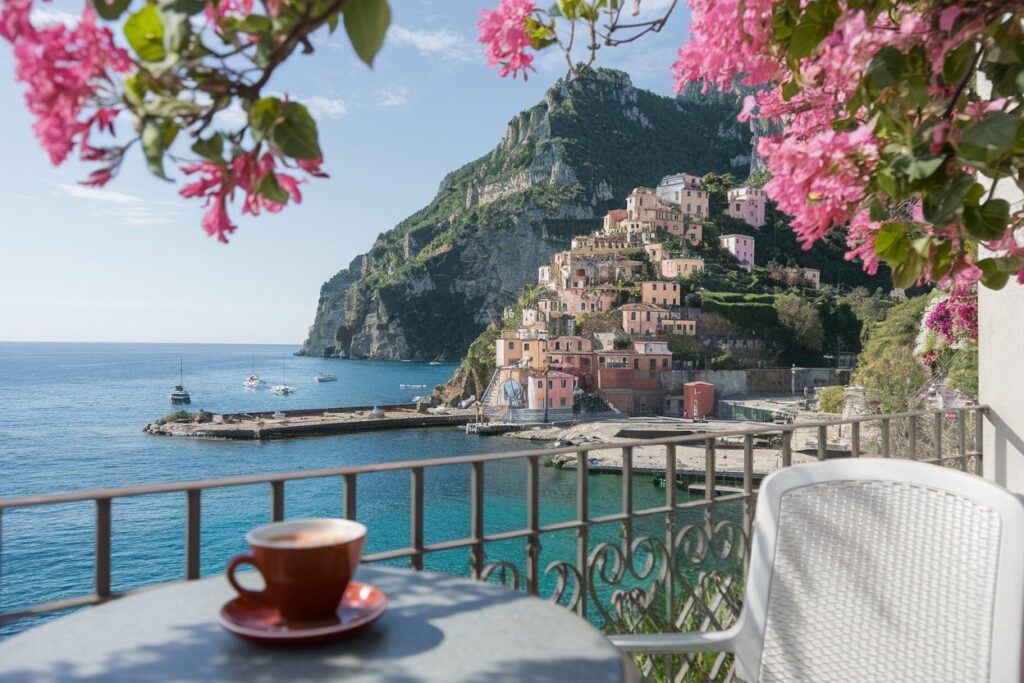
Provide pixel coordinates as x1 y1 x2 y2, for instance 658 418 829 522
300 70 750 360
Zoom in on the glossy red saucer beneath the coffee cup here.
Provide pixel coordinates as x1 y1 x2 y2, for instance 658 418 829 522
220 581 387 646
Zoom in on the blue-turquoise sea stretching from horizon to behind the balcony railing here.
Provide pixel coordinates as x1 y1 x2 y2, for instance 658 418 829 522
0 342 737 638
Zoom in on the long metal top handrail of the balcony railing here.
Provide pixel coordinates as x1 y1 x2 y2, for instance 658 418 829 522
0 405 988 510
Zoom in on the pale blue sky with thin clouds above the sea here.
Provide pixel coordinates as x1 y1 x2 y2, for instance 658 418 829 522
0 0 689 345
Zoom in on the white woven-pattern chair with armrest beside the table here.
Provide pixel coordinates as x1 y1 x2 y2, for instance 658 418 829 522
611 458 1024 683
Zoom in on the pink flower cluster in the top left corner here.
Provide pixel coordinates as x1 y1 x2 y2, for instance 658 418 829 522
0 0 133 167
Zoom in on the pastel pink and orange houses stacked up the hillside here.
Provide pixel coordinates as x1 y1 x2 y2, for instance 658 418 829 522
480 173 835 421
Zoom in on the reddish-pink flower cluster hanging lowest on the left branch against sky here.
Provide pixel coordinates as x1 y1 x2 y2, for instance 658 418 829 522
180 150 327 243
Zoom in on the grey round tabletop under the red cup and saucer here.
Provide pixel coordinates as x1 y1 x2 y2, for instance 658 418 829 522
0 566 637 683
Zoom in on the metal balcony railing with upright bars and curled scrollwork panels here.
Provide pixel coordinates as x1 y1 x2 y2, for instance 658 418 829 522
0 407 985 680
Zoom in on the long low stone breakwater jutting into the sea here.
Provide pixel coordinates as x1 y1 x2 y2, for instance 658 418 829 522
142 403 477 440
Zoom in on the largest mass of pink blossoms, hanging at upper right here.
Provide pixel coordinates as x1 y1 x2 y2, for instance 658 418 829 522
673 0 1011 284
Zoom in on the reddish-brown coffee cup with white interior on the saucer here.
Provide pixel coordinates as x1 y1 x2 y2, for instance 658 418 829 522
227 518 367 622
